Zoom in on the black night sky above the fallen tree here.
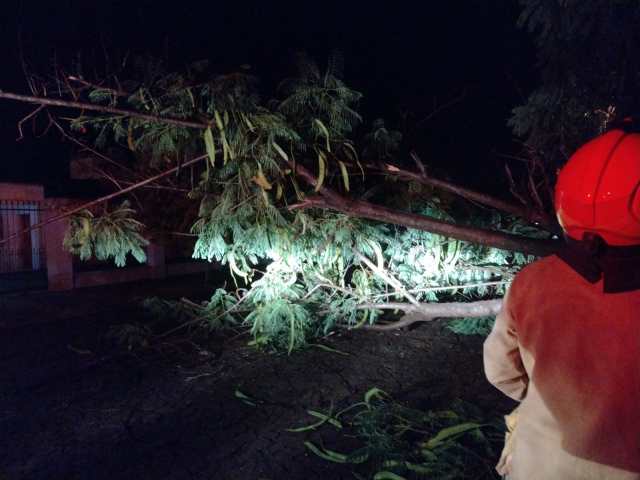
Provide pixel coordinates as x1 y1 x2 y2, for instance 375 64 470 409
0 0 535 194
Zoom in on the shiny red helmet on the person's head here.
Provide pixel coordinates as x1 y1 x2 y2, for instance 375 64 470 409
555 130 640 245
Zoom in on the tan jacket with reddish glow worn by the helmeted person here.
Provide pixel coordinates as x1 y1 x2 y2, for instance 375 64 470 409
484 256 640 480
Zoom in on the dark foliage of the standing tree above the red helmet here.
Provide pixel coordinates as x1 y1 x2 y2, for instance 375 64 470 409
509 0 640 162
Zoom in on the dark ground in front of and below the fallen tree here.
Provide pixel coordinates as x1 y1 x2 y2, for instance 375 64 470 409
0 277 512 480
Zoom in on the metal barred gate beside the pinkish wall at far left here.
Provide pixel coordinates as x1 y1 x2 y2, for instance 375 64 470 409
0 200 47 293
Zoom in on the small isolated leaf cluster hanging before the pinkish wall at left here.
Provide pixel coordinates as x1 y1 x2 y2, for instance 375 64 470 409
64 201 149 267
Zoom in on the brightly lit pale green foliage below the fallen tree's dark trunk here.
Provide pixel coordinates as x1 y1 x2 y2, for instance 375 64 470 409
190 200 531 351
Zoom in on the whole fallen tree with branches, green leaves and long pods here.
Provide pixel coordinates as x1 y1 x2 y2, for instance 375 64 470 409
0 52 560 350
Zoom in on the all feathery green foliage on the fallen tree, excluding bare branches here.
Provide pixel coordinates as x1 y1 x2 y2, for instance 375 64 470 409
62 54 539 352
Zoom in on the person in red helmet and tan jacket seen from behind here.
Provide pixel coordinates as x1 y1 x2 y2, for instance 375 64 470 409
484 124 640 480
